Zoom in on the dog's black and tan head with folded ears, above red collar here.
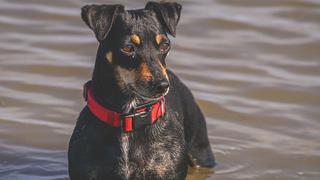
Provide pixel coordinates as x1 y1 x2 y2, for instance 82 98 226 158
81 2 181 99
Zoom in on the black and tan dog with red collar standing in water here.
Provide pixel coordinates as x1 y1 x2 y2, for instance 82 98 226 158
68 2 215 180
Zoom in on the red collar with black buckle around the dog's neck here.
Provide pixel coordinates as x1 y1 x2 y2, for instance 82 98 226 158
83 81 166 132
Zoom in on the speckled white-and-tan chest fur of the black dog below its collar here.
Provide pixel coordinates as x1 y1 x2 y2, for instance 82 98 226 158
119 129 185 179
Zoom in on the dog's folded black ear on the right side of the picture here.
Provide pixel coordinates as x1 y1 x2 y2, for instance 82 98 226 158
145 1 182 37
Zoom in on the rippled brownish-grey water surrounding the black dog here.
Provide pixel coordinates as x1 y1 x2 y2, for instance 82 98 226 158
0 0 320 180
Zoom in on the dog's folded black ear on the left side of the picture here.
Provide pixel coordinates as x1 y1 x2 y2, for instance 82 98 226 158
81 4 124 41
